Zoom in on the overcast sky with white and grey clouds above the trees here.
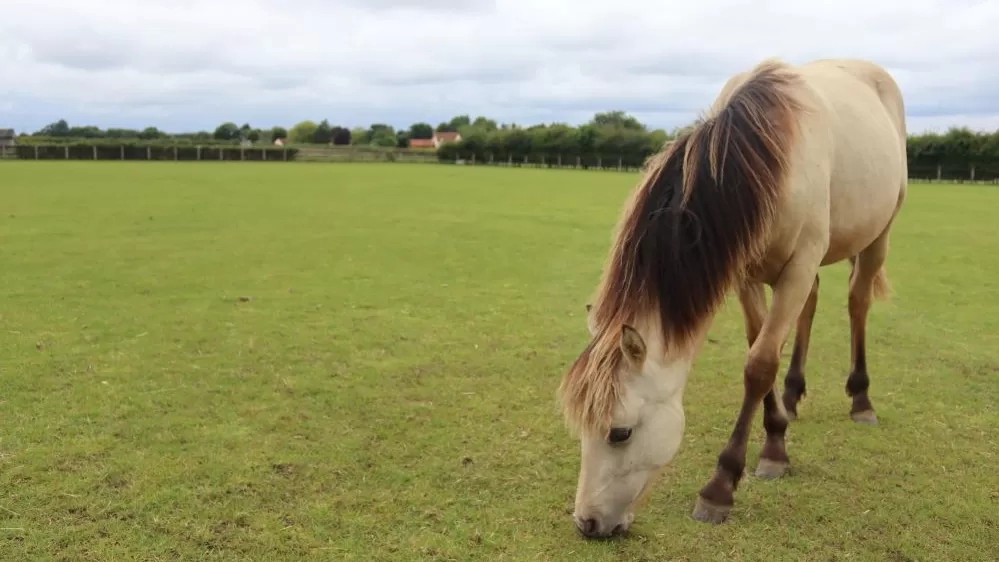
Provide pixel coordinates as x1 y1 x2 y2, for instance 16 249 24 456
0 0 999 132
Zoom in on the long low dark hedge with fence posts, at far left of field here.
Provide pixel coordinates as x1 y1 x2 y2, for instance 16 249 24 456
15 143 298 162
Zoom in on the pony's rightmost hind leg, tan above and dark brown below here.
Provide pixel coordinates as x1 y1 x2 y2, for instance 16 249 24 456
846 242 888 425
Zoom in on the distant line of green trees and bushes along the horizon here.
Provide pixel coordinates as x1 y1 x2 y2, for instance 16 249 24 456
13 111 999 179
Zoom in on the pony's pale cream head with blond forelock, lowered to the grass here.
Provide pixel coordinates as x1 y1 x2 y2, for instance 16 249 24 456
561 305 708 538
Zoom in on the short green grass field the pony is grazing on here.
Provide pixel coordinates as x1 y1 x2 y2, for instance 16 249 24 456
0 162 999 562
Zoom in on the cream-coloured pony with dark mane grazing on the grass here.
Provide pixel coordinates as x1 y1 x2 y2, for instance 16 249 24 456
558 58 908 538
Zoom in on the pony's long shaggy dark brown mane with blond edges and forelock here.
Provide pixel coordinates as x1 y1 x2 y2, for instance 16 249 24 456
559 59 805 431
